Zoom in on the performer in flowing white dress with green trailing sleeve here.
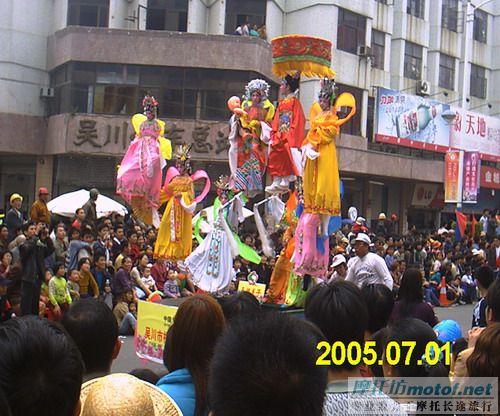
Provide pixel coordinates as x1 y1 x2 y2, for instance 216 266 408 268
184 176 260 294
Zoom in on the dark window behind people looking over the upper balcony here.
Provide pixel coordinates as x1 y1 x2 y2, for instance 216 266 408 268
224 0 267 35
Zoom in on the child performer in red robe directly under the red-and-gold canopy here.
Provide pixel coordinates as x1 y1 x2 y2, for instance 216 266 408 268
266 74 306 193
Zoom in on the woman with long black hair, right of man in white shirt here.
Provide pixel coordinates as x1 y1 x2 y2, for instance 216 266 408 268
390 268 438 327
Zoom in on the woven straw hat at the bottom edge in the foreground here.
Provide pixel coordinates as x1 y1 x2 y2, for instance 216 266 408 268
80 373 182 416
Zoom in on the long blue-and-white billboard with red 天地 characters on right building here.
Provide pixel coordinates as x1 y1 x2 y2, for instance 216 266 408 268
374 87 500 162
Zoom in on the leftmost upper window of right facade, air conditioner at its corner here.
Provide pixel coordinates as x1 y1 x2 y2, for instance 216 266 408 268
337 9 366 54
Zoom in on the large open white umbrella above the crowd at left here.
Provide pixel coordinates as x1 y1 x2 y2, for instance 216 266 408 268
47 189 128 218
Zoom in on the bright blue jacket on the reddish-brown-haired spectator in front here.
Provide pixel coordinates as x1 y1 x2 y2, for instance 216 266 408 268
156 368 196 416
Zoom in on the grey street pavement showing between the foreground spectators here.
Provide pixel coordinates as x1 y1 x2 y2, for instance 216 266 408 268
111 305 473 374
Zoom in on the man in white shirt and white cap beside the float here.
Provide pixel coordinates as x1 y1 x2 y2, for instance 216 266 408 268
345 233 393 290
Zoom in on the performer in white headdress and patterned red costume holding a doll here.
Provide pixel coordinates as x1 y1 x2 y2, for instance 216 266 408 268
228 79 275 197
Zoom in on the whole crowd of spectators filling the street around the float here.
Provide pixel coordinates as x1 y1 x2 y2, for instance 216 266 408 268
0 188 500 416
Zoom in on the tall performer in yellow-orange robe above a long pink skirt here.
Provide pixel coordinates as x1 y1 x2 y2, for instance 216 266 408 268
294 78 356 277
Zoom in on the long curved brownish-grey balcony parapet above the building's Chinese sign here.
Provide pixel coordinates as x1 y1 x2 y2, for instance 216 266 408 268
47 26 277 80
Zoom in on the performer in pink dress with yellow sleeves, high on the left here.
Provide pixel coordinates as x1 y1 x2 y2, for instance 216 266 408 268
116 95 172 225
